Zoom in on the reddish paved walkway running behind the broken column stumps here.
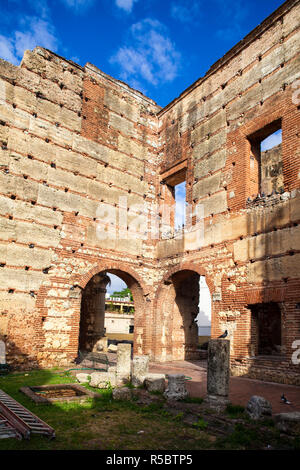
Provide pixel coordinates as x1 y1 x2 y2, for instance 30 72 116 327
149 361 300 414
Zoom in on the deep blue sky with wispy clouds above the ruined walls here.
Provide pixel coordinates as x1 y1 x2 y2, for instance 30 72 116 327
0 0 283 106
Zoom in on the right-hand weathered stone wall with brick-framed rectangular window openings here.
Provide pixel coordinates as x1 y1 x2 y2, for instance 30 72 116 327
156 1 300 383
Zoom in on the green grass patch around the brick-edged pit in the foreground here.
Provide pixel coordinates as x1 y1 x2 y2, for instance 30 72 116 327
0 369 216 452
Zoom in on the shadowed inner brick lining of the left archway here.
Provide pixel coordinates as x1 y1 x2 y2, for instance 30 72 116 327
78 269 144 353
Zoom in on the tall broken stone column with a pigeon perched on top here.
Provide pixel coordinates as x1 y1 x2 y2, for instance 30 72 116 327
205 339 230 411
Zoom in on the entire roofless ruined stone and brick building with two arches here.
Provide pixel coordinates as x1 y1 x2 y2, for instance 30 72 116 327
0 0 300 385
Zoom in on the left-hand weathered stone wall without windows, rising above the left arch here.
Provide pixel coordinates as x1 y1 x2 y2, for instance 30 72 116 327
0 48 159 365
